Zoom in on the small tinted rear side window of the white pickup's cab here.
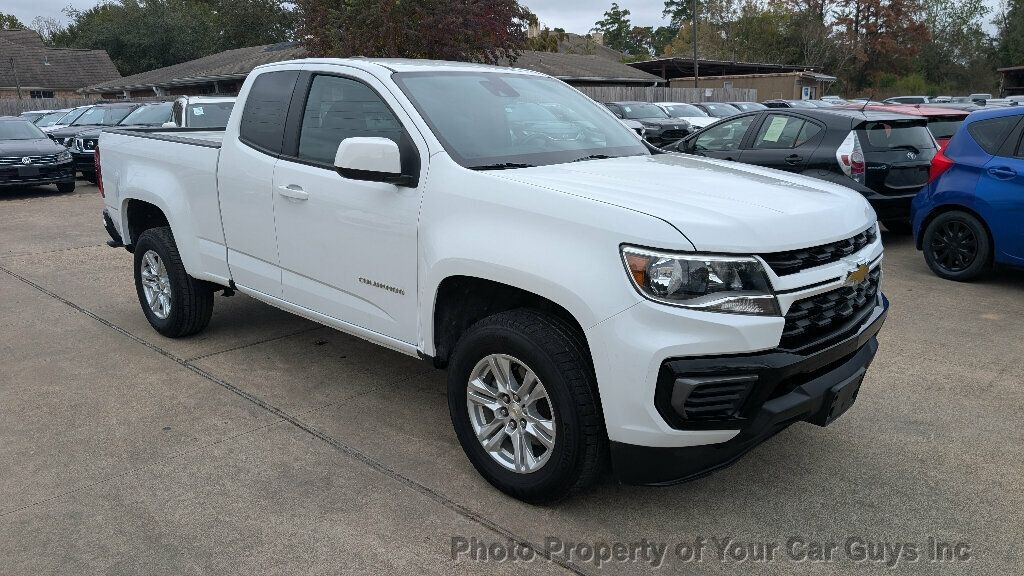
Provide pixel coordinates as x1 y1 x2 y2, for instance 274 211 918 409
239 70 299 154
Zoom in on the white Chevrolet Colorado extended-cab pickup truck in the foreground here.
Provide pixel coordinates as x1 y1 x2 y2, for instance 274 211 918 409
96 58 888 502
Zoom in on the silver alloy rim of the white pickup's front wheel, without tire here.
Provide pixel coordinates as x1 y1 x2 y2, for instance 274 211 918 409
466 354 555 474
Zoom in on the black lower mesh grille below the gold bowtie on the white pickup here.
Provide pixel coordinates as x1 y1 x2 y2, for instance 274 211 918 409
781 266 882 349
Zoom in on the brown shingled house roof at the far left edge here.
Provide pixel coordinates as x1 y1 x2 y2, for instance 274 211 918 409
0 30 121 90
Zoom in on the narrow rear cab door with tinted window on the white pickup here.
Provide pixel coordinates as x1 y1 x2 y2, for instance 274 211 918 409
217 70 299 298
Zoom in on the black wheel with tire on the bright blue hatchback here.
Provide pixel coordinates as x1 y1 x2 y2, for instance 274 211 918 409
923 211 992 282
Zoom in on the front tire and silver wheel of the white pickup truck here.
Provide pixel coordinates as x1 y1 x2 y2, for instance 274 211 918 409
447 310 607 504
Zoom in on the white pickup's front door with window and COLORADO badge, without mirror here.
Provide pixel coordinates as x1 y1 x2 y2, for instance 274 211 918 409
273 67 426 343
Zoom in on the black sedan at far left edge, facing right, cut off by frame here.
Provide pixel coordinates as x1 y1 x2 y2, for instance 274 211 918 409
0 116 75 193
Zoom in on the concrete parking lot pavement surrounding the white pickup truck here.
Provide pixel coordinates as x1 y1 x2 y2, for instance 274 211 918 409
0 182 1024 575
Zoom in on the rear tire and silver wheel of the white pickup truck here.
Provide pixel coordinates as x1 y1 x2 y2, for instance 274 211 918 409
135 227 213 338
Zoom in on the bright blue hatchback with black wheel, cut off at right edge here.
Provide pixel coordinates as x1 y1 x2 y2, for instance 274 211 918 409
910 107 1024 281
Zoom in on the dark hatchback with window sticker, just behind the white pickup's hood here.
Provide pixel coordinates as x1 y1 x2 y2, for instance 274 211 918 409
670 108 938 227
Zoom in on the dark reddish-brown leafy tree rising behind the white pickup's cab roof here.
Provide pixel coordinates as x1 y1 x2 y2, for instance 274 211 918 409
297 0 537 63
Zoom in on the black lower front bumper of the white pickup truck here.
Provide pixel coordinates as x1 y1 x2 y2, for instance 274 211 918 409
610 294 889 485
